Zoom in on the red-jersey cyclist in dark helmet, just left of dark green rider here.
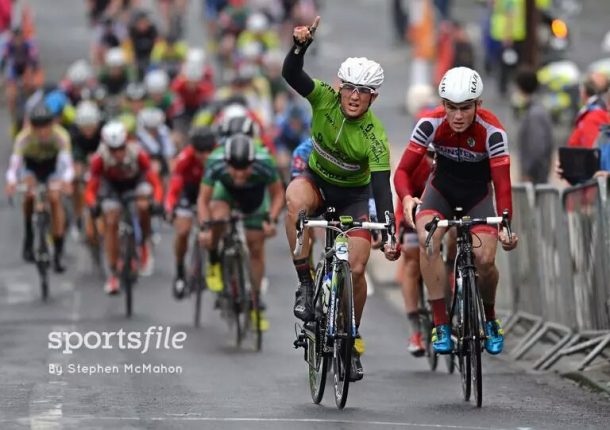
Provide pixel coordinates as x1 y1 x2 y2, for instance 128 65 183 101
164 127 216 299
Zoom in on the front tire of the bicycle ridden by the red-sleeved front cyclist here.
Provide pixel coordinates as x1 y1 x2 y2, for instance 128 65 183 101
466 269 483 408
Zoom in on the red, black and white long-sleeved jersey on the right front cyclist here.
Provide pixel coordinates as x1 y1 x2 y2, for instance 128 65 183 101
394 106 512 218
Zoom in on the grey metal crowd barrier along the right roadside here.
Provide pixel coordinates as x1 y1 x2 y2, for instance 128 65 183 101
498 179 610 369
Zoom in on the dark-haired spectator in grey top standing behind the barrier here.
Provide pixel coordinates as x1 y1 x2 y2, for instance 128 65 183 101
515 68 553 184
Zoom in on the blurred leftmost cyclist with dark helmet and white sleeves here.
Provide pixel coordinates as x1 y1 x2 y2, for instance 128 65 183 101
6 103 74 272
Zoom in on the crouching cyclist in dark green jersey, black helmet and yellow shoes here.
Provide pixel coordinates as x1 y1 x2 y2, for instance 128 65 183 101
197 134 284 330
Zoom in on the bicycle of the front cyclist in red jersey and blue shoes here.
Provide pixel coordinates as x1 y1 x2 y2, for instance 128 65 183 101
425 208 512 408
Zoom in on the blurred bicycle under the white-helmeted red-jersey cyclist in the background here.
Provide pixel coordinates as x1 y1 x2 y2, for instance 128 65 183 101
118 192 142 318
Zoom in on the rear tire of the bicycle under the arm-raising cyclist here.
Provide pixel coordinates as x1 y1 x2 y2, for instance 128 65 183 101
307 262 329 405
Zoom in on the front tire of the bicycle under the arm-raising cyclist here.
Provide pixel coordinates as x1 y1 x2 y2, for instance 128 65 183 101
333 262 354 409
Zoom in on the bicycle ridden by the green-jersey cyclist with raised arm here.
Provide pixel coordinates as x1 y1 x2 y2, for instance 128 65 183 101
294 207 396 409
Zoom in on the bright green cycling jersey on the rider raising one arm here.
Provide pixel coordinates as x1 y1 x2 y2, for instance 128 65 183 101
307 79 390 187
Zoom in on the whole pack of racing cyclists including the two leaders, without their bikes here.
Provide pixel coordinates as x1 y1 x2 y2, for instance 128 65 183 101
6 0 517 380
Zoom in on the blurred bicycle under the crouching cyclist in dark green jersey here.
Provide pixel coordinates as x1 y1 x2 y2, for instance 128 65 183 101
204 211 263 351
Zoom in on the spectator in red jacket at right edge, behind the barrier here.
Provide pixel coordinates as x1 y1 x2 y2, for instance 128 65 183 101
568 72 610 148
